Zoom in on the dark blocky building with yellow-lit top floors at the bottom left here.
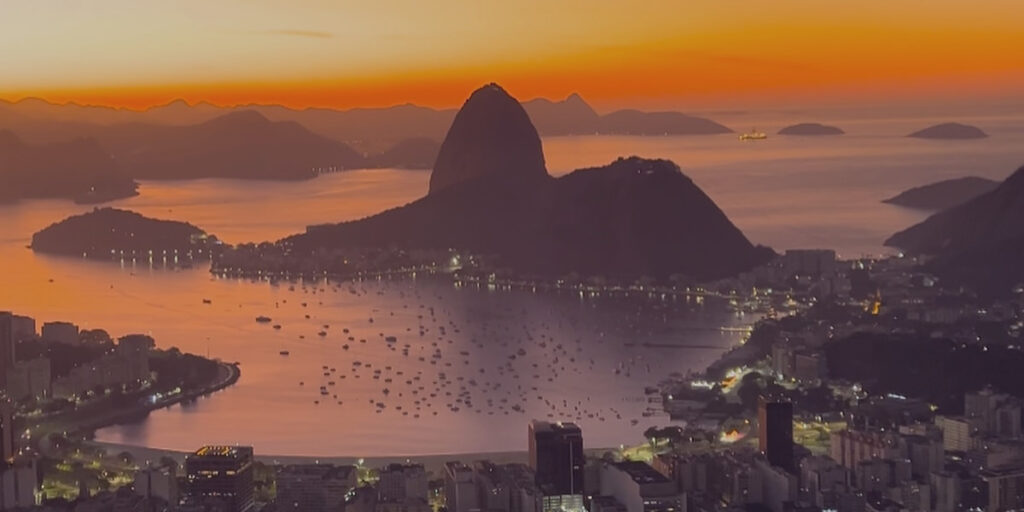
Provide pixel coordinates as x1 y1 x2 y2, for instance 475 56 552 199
185 446 254 512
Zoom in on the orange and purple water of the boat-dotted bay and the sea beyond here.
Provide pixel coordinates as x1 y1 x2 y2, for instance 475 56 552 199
0 109 1024 456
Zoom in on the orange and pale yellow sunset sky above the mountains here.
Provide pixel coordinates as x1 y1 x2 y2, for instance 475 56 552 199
0 0 1024 109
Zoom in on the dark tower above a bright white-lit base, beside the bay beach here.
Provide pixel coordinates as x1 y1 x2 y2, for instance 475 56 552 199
529 420 585 496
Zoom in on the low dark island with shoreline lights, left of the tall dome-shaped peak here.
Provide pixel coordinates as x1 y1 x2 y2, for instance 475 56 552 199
32 208 219 259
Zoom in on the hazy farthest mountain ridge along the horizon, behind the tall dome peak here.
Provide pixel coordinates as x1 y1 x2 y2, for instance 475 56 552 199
0 94 732 152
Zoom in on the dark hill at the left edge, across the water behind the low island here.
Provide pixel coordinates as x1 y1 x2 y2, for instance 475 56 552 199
0 130 137 203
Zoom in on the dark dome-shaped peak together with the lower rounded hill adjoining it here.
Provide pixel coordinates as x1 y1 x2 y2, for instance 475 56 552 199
286 84 773 280
